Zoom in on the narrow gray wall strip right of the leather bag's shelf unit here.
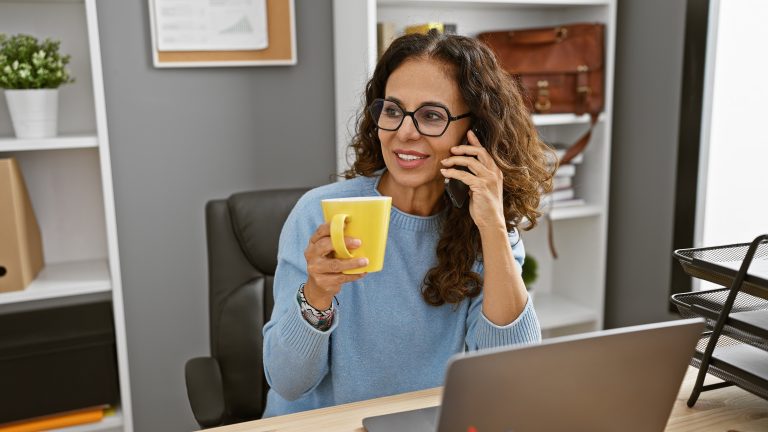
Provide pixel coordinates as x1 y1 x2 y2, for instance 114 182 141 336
605 0 686 327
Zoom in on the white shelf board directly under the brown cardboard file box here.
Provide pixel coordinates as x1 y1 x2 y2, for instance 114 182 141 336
0 259 112 305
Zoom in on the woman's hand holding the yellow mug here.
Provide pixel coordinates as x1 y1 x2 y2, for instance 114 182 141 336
304 223 368 310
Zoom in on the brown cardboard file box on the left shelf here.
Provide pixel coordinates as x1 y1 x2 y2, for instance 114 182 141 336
0 158 43 292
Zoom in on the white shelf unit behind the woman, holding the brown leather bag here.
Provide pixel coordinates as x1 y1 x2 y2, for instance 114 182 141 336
333 0 616 337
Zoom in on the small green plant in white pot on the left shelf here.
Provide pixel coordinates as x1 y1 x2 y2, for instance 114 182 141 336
0 33 74 138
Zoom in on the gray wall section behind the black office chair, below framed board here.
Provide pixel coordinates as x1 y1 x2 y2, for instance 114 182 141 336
98 0 335 431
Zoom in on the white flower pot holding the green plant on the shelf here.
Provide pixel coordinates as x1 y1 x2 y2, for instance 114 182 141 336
5 89 59 138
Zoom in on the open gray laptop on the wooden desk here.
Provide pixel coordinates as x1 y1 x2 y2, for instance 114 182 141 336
363 319 704 432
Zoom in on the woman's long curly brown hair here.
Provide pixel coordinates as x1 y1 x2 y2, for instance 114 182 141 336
343 31 555 306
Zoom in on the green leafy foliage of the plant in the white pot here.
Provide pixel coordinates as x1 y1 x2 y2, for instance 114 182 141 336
0 33 75 90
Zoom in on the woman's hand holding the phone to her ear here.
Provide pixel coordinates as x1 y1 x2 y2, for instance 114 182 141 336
440 130 506 231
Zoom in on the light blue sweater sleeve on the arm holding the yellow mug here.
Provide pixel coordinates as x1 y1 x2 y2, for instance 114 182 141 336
264 194 339 400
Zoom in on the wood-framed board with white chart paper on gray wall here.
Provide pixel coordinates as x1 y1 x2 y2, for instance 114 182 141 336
149 0 296 68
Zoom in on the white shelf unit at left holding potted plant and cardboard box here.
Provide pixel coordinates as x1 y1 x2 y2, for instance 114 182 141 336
0 0 133 432
